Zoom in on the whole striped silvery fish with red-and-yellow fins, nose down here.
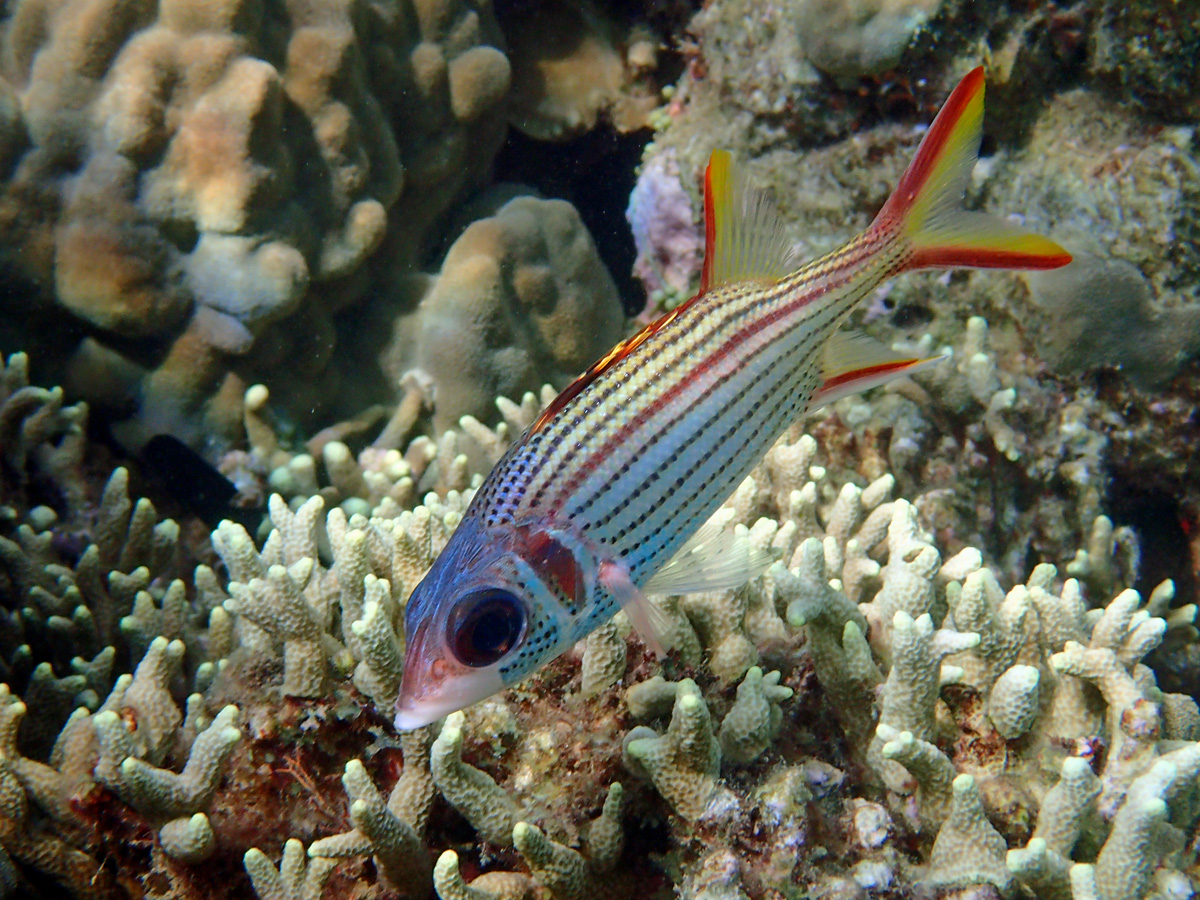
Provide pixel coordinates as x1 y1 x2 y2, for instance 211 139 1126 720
395 67 1070 730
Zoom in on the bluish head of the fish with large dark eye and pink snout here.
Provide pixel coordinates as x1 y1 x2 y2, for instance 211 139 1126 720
396 517 576 730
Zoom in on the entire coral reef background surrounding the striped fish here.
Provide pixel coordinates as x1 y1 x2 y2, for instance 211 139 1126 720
0 0 1200 900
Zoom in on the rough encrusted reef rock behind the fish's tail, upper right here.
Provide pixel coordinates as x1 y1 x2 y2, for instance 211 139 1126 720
629 0 1200 600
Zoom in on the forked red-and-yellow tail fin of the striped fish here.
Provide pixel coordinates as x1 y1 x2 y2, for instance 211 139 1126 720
871 66 1070 270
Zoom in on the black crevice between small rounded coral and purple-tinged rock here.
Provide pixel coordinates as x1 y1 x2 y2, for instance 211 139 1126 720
496 125 650 316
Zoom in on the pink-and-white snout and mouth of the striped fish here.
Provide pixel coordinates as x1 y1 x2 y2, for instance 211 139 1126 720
395 625 504 731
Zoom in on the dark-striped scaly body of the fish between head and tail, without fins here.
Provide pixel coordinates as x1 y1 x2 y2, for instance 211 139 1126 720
504 239 900 583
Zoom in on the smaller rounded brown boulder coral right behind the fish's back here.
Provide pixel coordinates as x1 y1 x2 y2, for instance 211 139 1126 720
383 197 624 434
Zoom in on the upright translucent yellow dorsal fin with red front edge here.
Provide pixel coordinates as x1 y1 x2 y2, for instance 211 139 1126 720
700 150 796 294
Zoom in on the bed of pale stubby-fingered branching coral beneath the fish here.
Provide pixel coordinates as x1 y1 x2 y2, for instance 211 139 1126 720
4 381 1200 900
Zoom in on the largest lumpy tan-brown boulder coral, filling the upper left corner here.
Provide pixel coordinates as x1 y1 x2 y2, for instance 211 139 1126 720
0 0 510 445
